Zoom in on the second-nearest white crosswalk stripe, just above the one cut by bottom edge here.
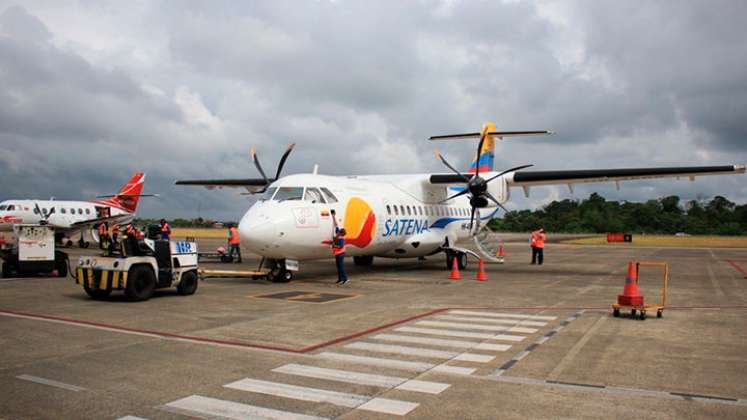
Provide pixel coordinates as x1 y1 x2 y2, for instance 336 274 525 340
223 378 420 416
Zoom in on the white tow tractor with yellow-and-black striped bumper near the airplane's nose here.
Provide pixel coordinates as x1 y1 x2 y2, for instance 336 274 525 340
75 238 198 301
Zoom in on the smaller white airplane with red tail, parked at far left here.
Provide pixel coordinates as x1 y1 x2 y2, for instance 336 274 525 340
0 172 155 248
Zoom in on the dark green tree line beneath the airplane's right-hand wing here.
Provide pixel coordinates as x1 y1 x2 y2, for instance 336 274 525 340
490 193 747 235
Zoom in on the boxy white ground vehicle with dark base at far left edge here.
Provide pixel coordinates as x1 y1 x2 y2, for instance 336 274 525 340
0 224 68 278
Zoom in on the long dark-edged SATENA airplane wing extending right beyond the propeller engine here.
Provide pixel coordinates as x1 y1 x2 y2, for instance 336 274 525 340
508 165 745 194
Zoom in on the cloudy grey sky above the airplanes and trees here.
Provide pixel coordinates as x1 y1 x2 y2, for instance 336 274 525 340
0 0 747 219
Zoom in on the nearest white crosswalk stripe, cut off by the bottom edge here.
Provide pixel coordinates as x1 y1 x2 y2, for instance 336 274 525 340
164 395 325 420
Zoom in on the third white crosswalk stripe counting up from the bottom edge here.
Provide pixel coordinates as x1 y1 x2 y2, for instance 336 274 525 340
272 363 449 394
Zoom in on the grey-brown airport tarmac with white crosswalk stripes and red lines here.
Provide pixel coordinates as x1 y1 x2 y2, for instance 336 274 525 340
0 240 747 419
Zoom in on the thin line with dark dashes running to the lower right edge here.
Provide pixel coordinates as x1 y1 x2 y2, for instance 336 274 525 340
490 375 747 406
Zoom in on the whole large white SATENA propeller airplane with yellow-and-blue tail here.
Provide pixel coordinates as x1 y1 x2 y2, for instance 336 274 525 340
176 122 745 282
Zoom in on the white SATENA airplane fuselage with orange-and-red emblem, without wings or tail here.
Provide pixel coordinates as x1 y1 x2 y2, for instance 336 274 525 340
239 173 508 260
